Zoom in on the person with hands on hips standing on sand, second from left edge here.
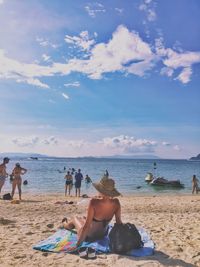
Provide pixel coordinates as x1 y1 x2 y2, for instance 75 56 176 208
11 163 27 200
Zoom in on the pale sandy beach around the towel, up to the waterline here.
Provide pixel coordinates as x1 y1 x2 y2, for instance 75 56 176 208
0 194 200 267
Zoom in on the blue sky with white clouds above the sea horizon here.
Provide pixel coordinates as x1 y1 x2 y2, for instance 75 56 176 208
0 0 200 159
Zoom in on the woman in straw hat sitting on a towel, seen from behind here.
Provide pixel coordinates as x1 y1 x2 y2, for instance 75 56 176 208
62 176 122 246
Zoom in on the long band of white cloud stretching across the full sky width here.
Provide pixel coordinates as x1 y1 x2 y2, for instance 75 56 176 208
0 25 200 88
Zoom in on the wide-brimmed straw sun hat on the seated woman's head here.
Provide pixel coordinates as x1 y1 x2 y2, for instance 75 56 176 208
93 176 121 197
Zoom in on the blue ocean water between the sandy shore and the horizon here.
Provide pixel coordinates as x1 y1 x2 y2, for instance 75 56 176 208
2 158 200 195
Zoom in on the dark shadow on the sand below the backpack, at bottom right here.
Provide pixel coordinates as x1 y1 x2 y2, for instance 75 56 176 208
119 250 196 267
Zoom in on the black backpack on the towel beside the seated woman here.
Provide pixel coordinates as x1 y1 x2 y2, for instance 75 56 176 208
109 223 143 254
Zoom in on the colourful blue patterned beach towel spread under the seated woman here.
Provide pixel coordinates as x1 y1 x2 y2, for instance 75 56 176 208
33 227 154 257
